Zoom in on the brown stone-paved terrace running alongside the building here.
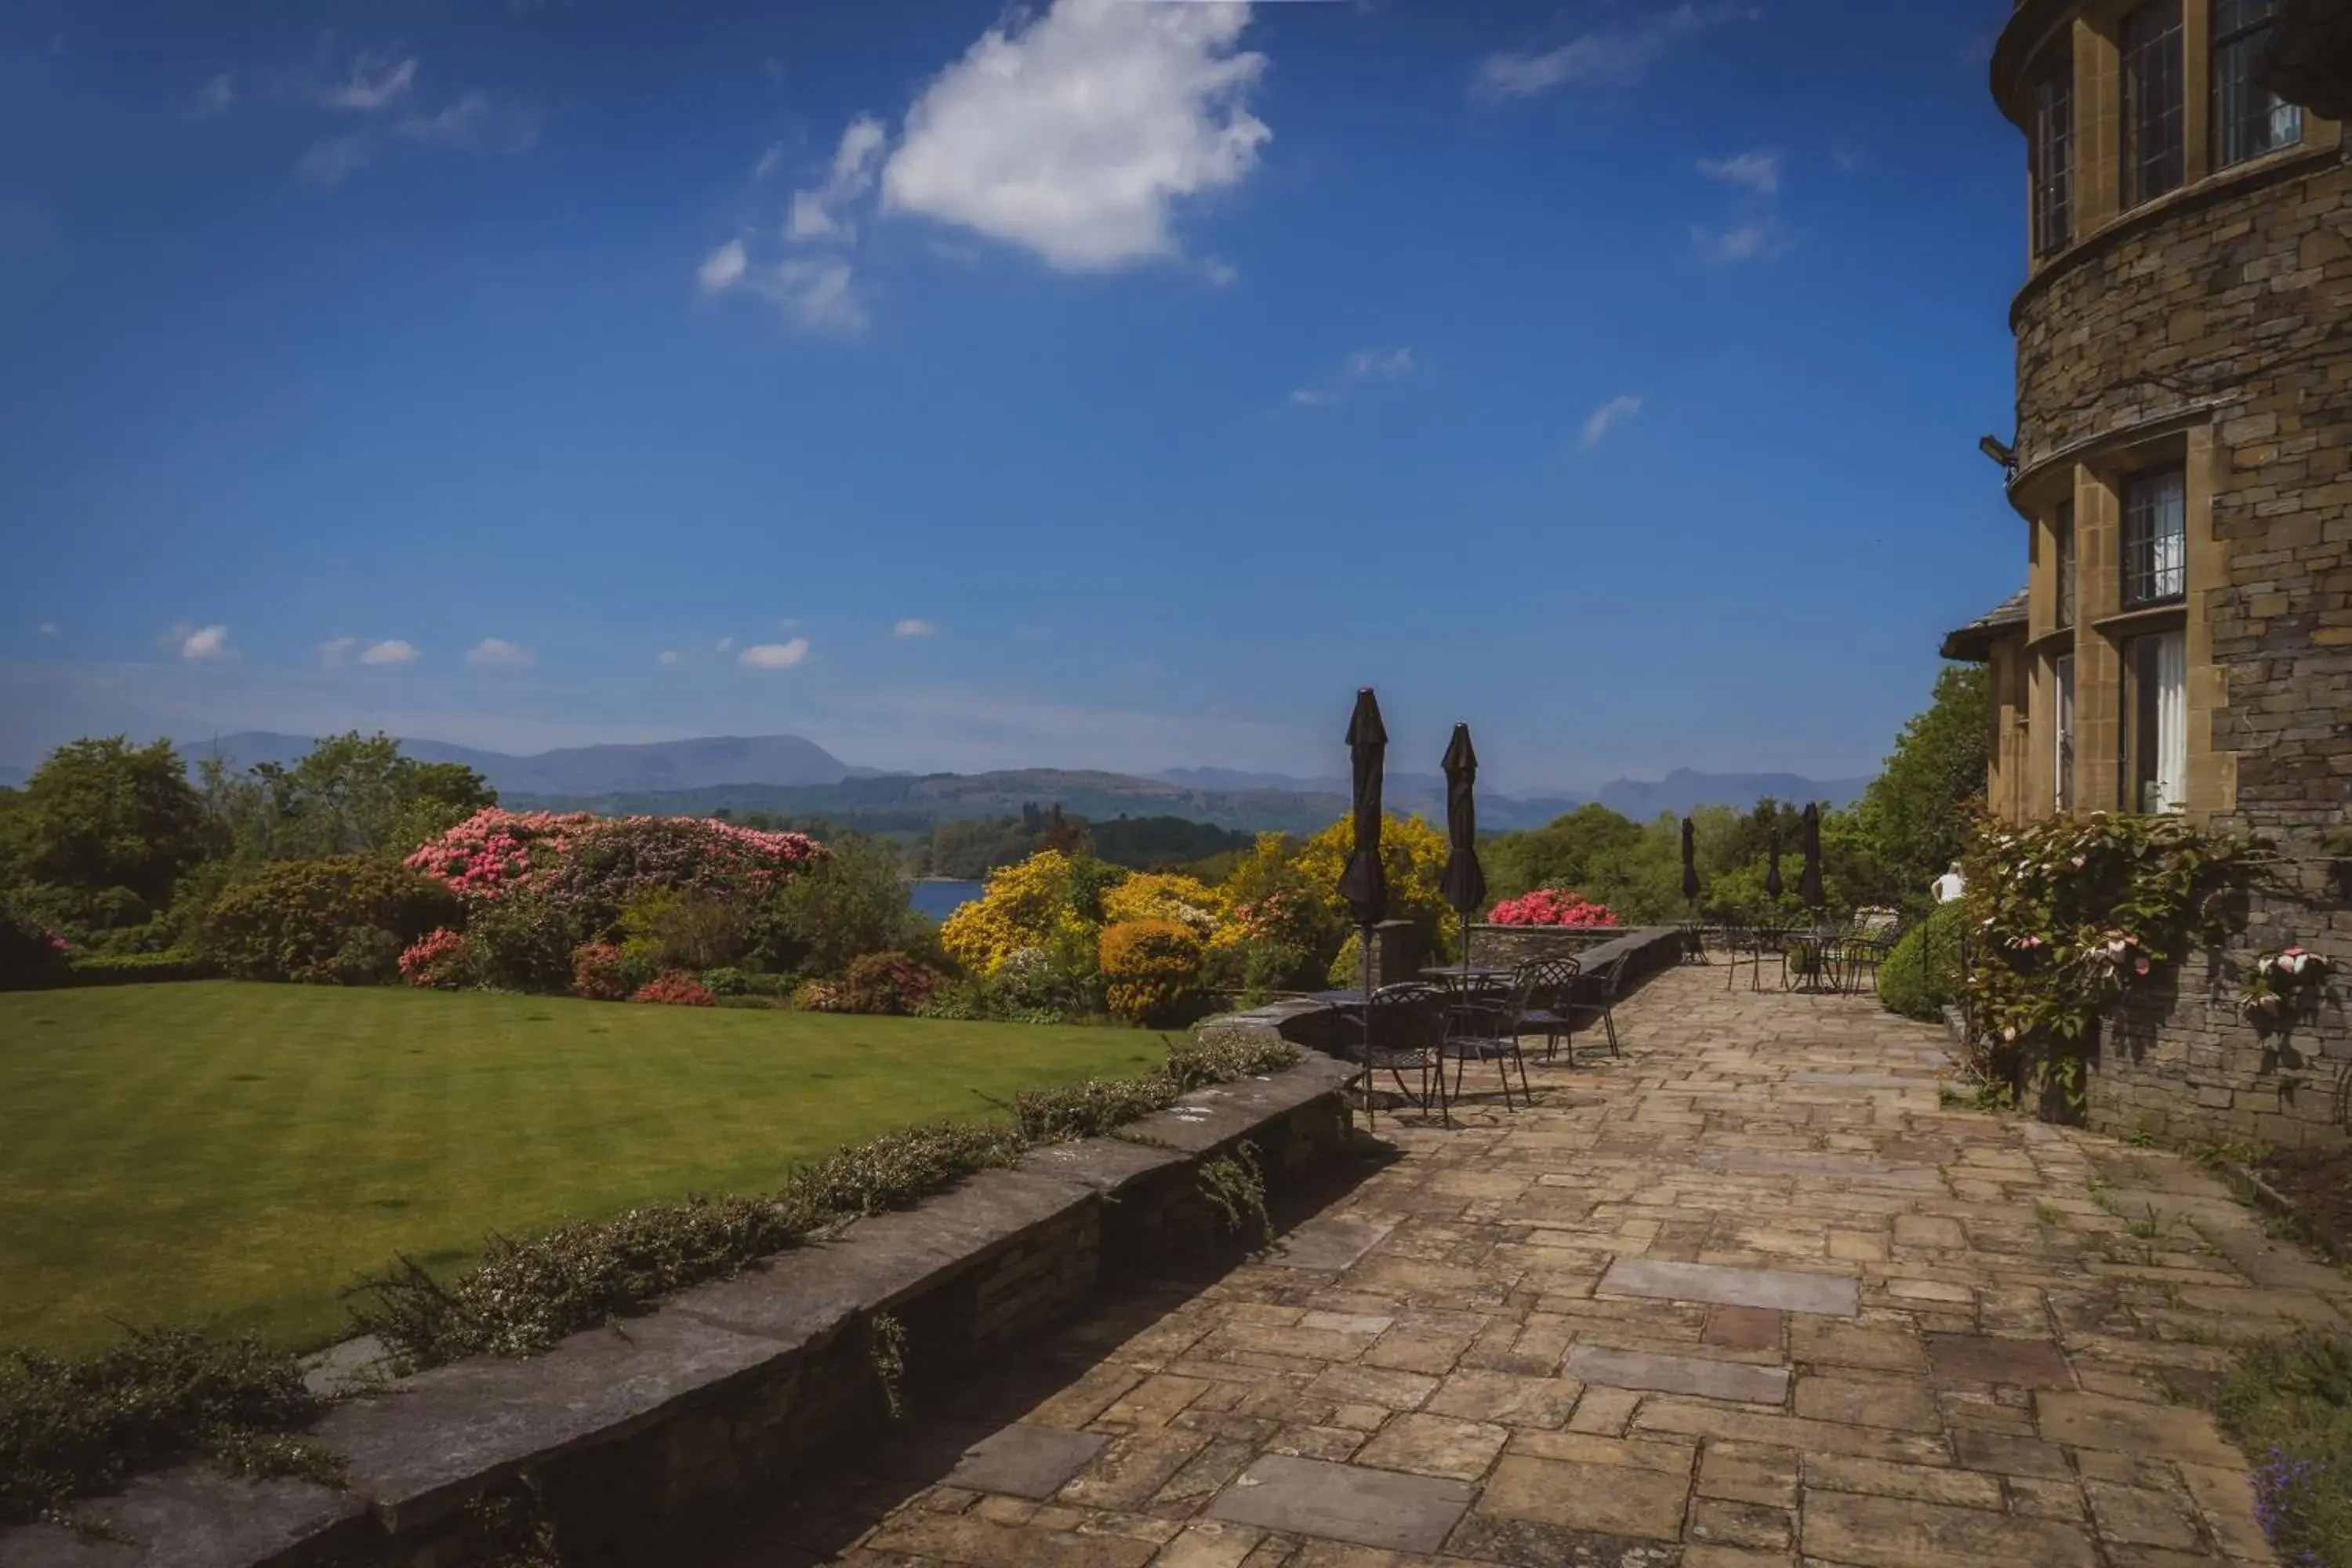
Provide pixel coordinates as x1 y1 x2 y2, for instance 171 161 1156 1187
701 968 2352 1568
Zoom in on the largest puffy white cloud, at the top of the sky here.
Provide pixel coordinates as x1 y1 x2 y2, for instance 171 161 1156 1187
882 0 1272 270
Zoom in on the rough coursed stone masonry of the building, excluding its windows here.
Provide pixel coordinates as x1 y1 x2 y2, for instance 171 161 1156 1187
2013 148 2352 1145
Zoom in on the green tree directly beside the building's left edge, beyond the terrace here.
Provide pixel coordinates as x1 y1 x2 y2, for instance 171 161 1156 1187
1860 666 1992 909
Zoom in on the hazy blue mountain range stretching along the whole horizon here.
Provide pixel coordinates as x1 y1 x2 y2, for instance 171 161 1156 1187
0 731 1867 832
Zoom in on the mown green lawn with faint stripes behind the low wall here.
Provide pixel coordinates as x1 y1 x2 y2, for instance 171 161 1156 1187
0 980 1164 1349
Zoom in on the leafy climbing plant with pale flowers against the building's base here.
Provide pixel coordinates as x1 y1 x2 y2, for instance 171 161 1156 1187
1962 811 2272 1100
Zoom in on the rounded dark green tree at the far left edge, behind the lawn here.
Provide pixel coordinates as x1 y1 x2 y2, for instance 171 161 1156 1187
5 736 205 938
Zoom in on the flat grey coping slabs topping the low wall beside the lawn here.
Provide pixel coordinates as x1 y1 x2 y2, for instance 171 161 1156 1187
0 1053 1352 1568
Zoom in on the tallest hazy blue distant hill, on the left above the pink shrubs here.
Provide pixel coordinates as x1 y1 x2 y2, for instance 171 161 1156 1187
179 731 868 797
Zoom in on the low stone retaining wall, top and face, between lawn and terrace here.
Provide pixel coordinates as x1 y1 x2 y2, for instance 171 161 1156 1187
0 1053 1350 1568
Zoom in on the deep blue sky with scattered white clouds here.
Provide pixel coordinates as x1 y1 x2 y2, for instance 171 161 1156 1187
0 0 2023 787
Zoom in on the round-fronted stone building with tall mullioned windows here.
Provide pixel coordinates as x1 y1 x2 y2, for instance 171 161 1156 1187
1943 0 2352 1142
